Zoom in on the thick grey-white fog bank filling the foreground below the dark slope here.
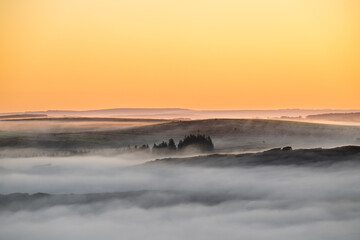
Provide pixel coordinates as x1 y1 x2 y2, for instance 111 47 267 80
0 154 360 240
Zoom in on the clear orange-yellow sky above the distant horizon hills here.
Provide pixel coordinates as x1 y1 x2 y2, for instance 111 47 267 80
0 0 360 112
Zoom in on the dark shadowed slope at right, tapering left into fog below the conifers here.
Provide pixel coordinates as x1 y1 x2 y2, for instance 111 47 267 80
145 146 360 167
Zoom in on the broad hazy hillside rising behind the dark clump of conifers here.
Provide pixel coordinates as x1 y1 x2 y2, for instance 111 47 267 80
0 119 360 158
